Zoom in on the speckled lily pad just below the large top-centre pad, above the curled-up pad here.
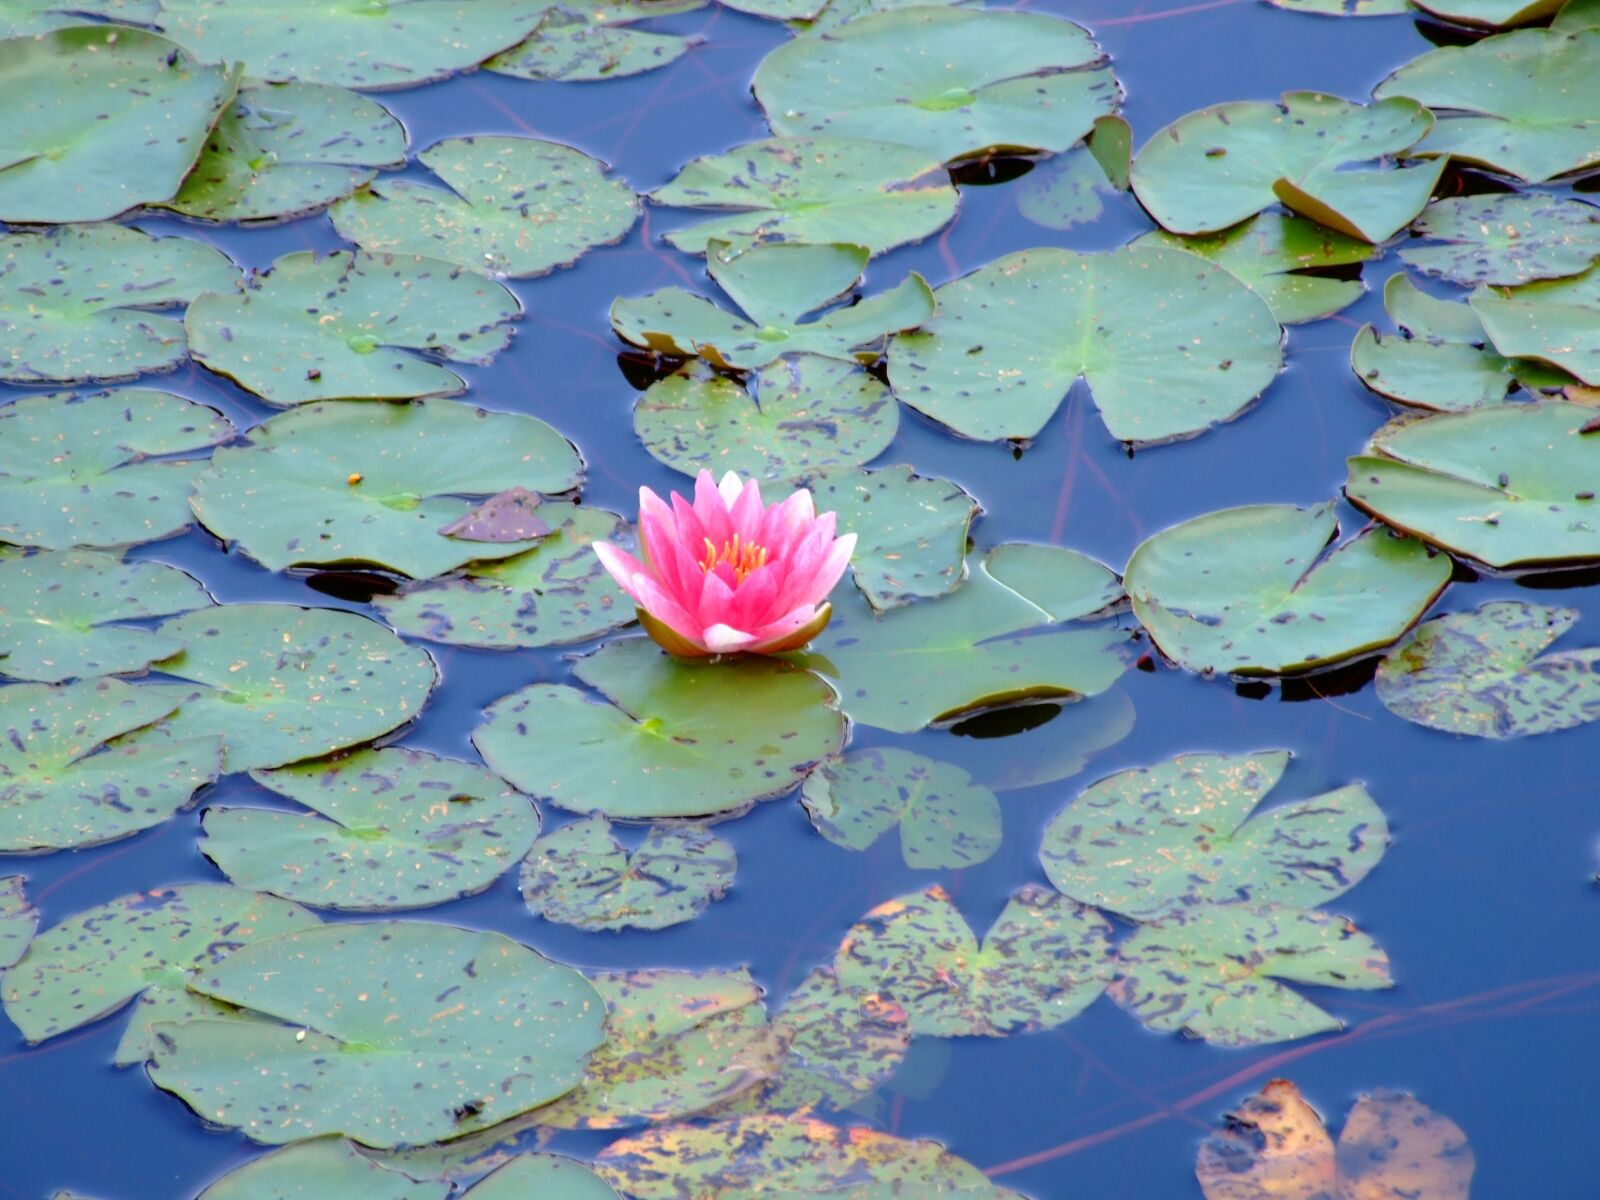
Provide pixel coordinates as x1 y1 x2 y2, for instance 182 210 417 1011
650 138 960 254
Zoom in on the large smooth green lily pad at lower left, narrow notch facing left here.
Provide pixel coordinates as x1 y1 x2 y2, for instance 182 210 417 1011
149 922 603 1147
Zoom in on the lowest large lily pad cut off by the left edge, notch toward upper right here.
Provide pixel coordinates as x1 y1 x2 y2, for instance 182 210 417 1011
0 678 222 854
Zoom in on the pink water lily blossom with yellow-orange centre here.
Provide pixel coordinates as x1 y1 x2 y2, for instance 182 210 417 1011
595 470 856 658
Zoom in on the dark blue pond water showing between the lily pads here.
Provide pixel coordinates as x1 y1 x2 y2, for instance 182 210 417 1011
0 0 1600 1200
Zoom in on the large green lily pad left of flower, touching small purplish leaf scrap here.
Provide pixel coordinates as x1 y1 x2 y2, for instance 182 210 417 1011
194 400 582 579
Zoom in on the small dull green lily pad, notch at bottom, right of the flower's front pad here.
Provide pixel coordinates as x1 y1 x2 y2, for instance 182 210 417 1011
800 746 1000 870
